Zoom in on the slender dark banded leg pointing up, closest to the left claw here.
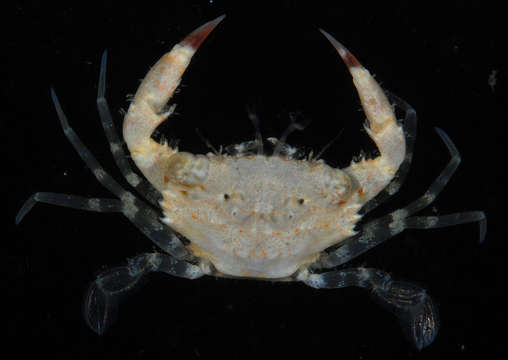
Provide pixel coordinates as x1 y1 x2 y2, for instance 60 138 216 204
97 51 161 208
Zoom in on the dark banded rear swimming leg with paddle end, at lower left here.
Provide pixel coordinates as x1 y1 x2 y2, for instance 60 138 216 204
83 253 204 335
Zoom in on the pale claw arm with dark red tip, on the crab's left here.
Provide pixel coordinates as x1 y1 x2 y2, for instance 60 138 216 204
123 15 225 190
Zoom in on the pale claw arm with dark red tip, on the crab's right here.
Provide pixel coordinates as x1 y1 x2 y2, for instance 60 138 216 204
319 29 406 203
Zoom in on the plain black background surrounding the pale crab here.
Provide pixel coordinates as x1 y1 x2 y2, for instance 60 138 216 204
7 1 507 359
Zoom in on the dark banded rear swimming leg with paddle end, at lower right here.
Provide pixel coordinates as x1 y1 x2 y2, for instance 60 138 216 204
299 268 439 350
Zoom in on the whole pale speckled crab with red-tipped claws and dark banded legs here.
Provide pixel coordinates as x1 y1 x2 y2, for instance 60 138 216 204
16 15 486 349
